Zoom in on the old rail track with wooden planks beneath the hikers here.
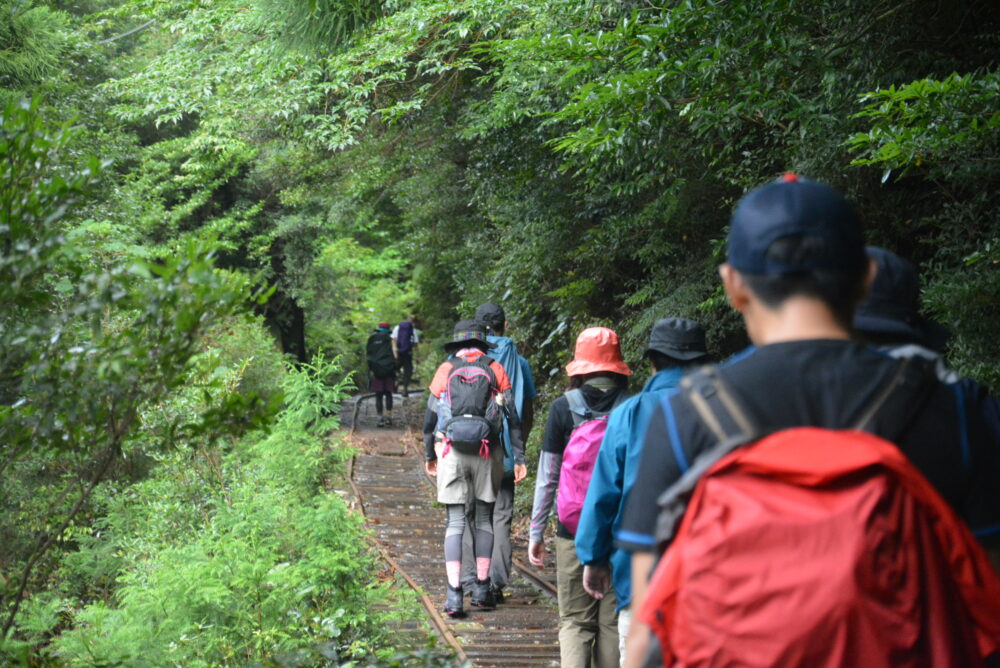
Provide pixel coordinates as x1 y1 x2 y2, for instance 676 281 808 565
345 395 559 667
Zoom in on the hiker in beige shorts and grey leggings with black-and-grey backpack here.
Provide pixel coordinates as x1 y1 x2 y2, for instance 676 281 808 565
424 320 527 617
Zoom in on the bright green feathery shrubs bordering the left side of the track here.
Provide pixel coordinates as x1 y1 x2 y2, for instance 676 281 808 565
39 359 410 665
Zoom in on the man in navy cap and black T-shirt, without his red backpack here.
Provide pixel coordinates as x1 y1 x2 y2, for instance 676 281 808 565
616 174 1000 666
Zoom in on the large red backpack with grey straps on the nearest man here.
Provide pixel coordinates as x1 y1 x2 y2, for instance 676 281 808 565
639 364 1000 668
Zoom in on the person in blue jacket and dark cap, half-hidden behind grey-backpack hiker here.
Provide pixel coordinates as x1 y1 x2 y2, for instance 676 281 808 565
462 302 537 603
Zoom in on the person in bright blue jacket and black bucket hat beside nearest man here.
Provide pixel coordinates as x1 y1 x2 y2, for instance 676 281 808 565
576 318 709 665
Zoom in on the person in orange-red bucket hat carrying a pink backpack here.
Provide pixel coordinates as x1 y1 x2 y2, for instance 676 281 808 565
528 327 632 668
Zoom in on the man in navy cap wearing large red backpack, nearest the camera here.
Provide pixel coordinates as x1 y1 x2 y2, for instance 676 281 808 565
617 175 1000 668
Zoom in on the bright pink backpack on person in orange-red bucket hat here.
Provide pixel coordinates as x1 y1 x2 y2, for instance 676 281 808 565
556 389 625 534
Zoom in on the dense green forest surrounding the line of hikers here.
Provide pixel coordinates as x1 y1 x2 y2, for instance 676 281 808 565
0 0 1000 665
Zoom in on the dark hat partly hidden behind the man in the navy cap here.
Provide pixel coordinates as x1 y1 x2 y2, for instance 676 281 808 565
853 246 948 350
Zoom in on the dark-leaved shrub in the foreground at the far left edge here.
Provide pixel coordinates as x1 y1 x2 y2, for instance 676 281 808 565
0 104 267 638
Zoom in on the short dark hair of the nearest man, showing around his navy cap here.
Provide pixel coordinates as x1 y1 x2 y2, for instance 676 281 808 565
740 237 868 327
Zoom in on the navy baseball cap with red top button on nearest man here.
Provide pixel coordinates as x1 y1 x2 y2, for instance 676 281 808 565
726 174 867 275
